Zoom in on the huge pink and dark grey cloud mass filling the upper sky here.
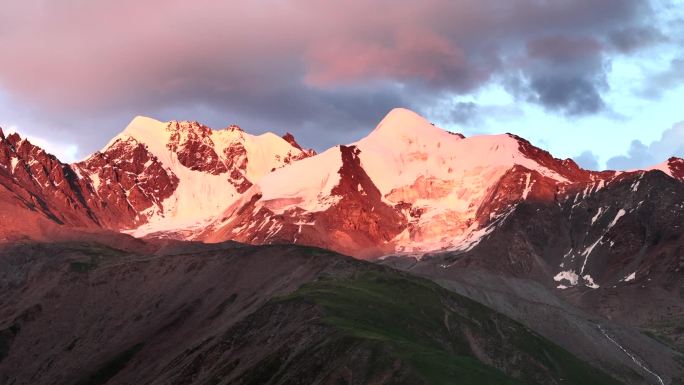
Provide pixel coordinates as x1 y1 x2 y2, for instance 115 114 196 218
0 0 658 155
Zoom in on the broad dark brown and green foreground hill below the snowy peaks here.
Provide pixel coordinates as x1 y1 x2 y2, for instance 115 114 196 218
0 242 634 385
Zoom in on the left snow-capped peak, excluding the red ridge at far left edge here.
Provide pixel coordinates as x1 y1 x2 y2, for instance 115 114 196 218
74 117 314 235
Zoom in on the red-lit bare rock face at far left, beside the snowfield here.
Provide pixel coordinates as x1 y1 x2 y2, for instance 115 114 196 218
0 127 183 228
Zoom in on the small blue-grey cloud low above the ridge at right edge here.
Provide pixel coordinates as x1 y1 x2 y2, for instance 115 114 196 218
607 122 684 170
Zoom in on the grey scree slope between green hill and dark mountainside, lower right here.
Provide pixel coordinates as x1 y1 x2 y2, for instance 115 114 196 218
383 258 684 385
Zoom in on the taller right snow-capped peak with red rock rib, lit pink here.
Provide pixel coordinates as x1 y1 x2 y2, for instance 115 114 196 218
197 109 677 257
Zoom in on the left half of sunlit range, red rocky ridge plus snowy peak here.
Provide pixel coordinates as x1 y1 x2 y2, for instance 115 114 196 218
0 117 315 235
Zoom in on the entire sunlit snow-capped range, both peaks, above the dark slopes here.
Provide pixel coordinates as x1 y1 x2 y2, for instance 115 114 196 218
0 109 684 258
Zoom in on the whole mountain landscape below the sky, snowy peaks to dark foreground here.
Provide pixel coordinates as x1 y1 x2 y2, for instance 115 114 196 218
0 109 684 384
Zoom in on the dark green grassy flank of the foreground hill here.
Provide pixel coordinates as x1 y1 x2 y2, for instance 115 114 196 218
272 268 617 385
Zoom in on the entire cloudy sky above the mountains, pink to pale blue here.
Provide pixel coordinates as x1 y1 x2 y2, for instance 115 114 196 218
0 0 684 169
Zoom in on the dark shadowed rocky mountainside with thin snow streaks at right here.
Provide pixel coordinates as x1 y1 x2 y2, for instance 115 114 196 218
398 166 684 302
